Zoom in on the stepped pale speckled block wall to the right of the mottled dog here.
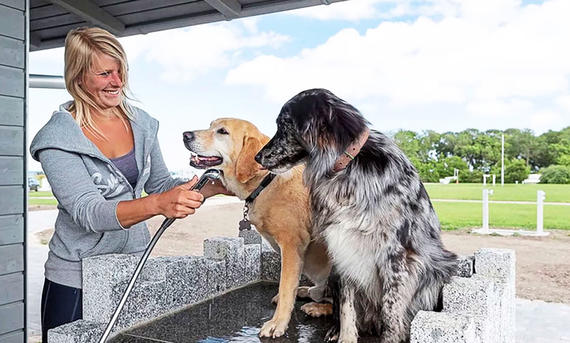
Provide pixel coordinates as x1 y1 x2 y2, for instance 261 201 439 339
410 249 515 343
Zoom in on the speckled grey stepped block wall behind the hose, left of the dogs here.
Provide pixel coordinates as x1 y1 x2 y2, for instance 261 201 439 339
48 231 280 343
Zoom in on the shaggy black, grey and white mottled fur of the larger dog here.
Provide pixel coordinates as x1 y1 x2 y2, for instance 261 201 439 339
256 89 457 343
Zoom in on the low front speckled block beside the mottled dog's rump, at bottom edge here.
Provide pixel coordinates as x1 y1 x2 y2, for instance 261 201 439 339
410 311 480 343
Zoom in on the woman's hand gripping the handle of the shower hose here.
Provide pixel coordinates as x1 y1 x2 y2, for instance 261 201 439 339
155 176 204 218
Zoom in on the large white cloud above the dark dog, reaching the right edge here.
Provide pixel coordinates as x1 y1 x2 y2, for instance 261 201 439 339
226 0 570 113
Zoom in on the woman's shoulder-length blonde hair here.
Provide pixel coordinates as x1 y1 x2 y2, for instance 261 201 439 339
64 27 133 139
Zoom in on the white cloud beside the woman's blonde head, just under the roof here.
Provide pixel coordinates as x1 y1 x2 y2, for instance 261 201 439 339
122 20 289 82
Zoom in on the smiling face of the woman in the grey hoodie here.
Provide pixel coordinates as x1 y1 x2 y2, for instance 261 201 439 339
82 53 123 110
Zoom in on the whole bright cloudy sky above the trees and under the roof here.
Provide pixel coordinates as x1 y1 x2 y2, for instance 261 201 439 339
28 0 570 172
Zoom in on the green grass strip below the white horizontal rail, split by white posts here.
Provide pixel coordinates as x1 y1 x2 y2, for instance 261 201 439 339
433 202 570 230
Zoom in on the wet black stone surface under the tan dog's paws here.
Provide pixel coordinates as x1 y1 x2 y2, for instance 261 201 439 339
111 282 377 343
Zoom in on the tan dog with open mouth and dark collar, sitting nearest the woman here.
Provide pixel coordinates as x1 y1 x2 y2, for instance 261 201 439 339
184 118 332 338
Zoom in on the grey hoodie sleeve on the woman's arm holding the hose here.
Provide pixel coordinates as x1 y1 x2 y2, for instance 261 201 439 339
38 149 124 232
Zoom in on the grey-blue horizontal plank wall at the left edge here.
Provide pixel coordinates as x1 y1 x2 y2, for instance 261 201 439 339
0 0 27 343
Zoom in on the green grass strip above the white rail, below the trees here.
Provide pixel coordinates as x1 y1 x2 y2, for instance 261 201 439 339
425 183 570 203
